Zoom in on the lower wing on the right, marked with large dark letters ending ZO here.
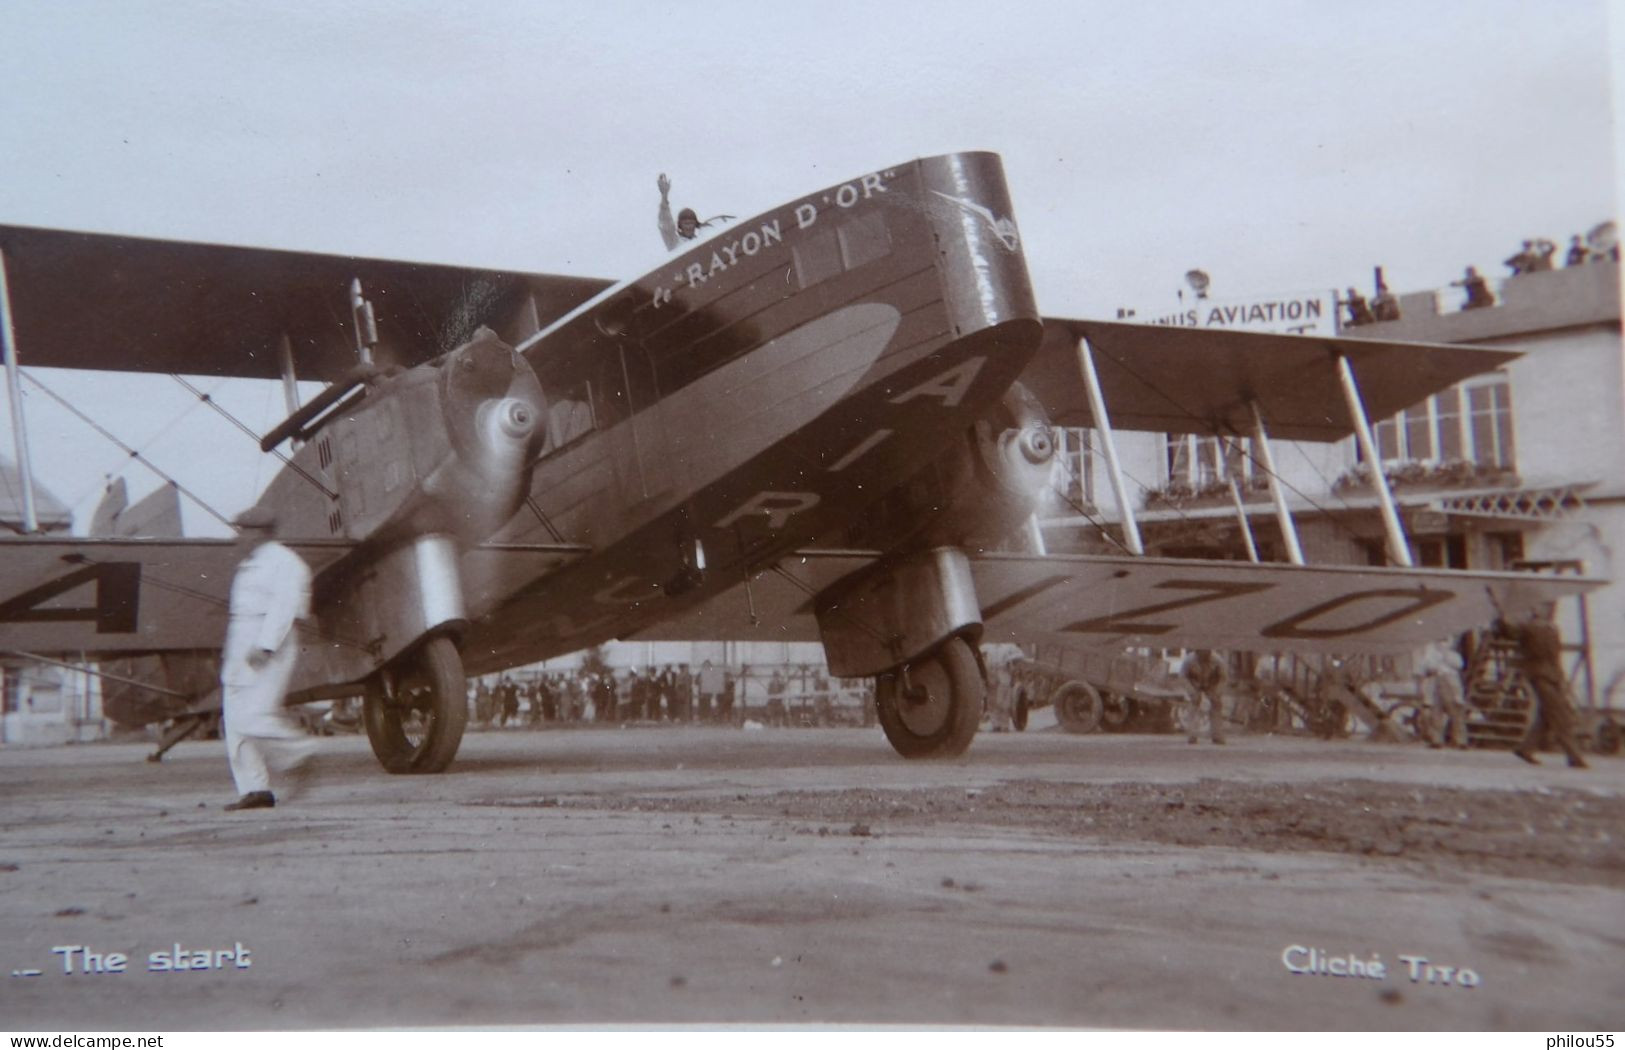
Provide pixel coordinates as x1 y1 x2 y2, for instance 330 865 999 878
644 551 1604 653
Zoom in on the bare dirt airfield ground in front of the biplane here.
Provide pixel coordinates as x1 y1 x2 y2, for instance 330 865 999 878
0 728 1625 1032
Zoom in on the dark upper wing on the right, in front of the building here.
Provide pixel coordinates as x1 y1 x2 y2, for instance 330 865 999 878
1021 317 1518 440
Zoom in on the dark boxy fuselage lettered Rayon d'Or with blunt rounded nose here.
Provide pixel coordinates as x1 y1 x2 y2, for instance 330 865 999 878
463 153 1040 673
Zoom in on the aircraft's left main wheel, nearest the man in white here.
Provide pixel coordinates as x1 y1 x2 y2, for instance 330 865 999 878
361 637 468 774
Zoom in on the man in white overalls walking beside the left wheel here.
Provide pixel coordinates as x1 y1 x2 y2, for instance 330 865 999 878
219 507 310 809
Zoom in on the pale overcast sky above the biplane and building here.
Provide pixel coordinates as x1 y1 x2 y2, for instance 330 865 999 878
0 0 1620 535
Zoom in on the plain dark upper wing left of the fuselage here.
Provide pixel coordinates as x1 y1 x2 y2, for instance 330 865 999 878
0 226 609 380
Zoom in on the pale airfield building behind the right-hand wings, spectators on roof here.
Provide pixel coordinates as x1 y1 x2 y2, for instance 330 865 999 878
1045 262 1625 709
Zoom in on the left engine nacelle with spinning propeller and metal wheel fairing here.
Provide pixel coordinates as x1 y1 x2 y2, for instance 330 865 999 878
265 328 546 688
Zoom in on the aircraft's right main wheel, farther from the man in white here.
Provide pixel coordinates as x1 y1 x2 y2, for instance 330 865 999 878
874 637 986 759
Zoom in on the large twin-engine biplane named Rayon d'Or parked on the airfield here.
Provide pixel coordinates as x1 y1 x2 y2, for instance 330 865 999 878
0 153 1586 772
